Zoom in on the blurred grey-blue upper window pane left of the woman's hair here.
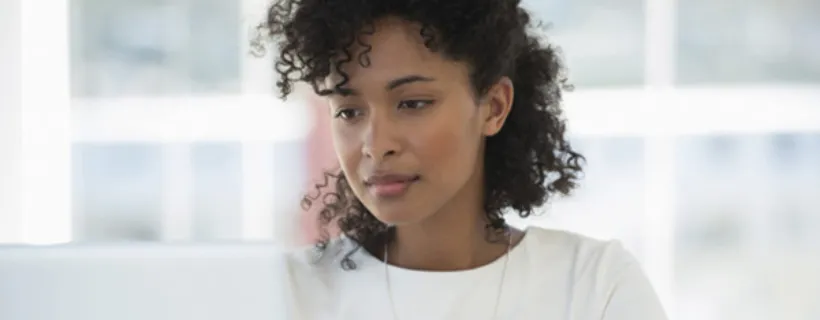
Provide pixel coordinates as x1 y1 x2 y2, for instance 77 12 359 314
70 0 243 97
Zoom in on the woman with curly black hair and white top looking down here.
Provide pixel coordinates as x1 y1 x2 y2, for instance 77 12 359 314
264 0 665 320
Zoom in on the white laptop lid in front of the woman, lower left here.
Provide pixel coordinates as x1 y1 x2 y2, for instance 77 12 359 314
0 244 288 320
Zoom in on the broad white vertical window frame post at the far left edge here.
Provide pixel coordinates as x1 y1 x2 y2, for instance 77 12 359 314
0 0 72 244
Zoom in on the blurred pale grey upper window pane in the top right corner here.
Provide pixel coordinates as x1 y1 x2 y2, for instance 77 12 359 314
677 0 820 84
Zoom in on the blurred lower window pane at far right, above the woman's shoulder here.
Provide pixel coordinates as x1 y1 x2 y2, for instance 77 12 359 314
675 134 820 319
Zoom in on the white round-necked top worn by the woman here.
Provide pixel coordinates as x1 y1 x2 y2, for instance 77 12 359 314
278 227 666 320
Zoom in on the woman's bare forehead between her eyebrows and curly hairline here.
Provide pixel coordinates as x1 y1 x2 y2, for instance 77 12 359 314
326 18 467 87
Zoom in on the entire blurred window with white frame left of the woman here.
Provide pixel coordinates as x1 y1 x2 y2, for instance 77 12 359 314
0 0 310 243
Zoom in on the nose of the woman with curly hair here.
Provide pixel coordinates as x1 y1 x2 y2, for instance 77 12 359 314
362 114 401 162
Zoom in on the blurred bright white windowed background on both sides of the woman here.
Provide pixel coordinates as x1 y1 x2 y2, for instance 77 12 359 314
0 0 820 320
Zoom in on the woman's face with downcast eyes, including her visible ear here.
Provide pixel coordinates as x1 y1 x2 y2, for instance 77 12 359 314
325 19 511 225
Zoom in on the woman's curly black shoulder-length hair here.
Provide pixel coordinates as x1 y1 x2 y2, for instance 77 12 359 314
260 0 584 269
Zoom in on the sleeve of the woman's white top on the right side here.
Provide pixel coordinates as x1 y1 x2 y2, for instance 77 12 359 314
601 246 668 320
